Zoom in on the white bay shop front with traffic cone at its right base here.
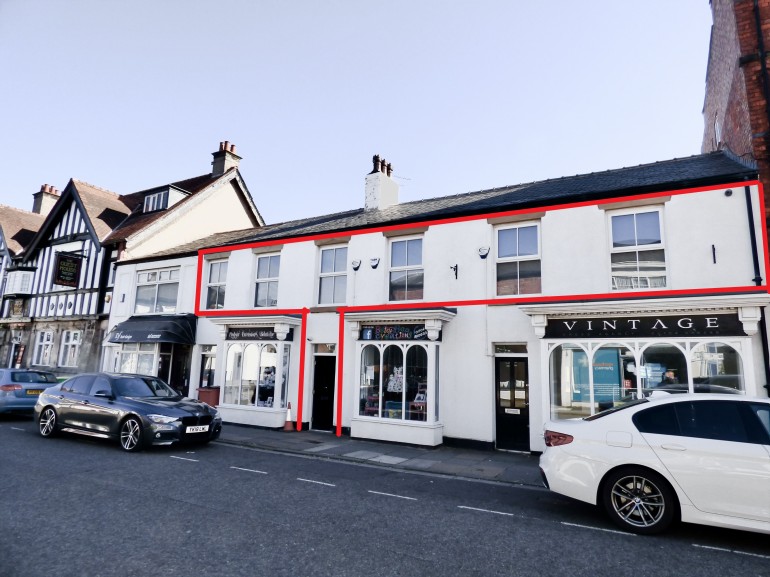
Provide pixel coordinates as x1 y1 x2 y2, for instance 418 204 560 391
212 316 301 428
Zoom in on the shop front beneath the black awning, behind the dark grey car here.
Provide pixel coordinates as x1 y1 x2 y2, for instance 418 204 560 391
106 314 197 396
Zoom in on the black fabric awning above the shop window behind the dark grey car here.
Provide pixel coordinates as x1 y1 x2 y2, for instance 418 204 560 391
107 315 198 345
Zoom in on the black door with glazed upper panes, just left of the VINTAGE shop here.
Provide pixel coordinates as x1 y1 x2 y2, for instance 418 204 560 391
495 357 529 451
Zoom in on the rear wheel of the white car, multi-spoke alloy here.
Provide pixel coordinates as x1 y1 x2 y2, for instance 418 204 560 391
602 467 679 535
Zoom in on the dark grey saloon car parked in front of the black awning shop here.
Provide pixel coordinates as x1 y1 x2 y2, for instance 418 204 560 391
35 373 222 451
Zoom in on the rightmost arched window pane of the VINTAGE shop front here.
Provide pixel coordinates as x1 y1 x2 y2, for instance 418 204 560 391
690 343 744 393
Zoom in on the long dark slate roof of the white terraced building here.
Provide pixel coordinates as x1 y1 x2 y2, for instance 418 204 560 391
126 151 757 260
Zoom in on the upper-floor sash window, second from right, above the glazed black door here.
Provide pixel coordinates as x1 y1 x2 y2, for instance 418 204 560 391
497 224 542 296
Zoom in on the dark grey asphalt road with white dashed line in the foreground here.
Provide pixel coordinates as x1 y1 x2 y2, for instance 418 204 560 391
0 417 770 577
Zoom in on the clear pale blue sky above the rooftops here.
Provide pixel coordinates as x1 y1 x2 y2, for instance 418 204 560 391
0 0 711 223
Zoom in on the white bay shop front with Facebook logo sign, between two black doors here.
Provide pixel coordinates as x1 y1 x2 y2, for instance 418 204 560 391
346 309 456 446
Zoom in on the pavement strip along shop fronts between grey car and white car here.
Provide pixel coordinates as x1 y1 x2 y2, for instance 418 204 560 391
213 423 542 487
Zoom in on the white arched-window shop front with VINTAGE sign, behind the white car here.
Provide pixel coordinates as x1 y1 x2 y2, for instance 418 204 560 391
523 297 767 440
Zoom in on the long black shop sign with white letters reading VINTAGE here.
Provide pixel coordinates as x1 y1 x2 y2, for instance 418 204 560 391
545 314 746 339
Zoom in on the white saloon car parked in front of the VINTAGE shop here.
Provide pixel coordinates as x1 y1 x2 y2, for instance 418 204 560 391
540 393 770 534
